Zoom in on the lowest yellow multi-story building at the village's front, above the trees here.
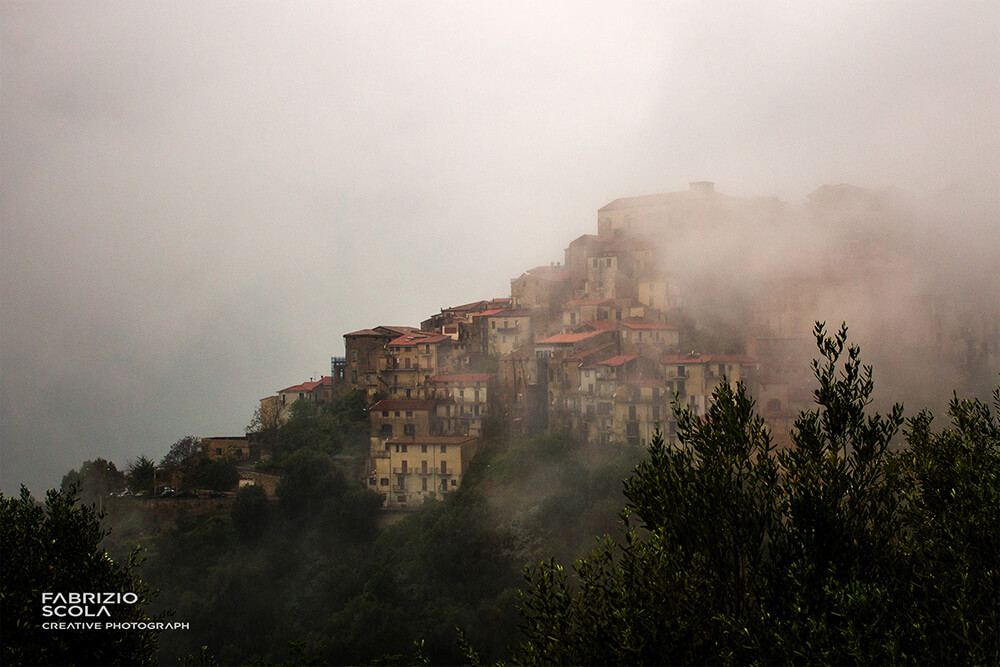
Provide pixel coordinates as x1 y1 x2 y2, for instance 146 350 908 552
368 436 478 509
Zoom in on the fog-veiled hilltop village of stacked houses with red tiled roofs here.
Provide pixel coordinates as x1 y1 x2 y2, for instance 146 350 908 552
211 182 997 509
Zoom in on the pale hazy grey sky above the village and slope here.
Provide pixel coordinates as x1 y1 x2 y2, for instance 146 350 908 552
0 0 1000 495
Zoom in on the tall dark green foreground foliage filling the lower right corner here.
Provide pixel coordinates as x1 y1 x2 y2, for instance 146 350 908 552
514 325 1000 664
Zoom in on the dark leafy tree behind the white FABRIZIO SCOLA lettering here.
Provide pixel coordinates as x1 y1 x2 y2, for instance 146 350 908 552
0 486 162 665
